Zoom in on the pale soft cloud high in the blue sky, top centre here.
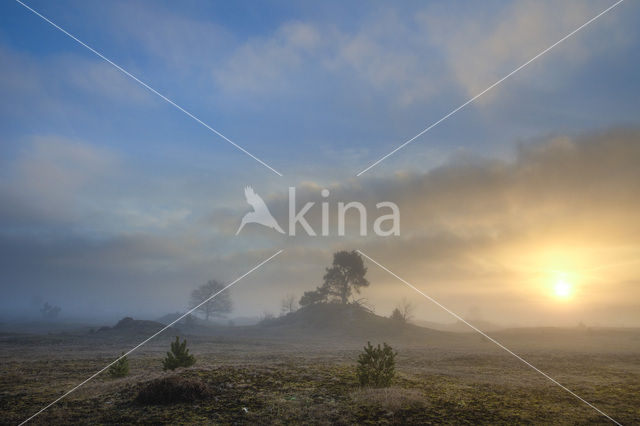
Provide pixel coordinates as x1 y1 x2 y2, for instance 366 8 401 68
214 11 442 107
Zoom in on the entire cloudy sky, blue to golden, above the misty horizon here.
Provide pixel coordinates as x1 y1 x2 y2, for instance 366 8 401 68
0 0 640 326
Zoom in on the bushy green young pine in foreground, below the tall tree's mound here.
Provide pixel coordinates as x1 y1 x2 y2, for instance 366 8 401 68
357 342 397 388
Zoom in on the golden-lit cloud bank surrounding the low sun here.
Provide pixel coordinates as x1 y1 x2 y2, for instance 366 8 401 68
226 129 640 323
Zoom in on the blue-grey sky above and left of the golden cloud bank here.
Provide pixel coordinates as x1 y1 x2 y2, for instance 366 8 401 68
0 0 640 321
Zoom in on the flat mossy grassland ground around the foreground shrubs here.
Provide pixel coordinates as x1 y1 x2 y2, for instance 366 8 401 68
0 329 640 424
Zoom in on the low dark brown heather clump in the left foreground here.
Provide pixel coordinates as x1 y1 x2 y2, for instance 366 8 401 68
136 376 209 405
